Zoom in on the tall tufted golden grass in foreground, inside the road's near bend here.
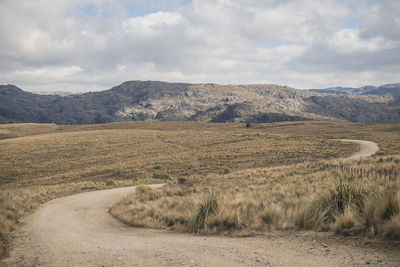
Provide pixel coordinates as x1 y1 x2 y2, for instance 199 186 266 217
111 156 400 239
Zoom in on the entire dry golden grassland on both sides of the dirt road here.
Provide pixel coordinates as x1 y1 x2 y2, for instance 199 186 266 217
0 122 400 257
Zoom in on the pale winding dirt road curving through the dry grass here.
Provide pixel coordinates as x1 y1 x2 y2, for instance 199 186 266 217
2 141 400 266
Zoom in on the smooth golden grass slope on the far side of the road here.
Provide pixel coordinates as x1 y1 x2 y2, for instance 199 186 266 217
0 123 368 187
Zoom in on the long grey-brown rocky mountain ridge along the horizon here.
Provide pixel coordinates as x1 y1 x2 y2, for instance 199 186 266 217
0 81 400 124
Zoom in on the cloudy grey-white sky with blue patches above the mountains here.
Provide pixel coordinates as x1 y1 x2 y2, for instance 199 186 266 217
0 0 400 91
